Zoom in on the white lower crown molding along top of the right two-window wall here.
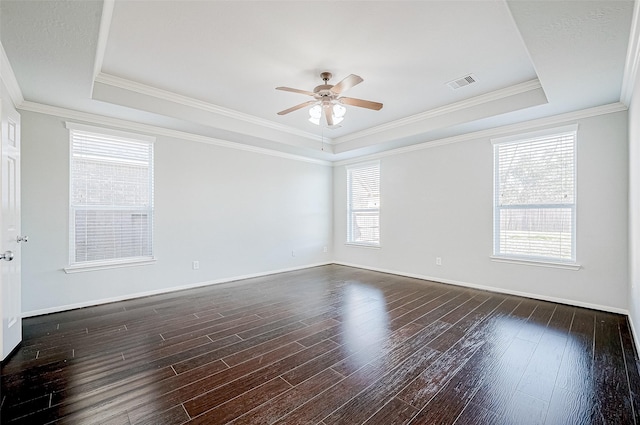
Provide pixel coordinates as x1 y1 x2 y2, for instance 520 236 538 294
333 102 628 167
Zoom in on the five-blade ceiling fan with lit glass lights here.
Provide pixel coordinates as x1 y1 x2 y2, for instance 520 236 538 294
276 72 382 128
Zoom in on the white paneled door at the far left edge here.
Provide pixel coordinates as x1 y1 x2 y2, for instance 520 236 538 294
0 97 22 360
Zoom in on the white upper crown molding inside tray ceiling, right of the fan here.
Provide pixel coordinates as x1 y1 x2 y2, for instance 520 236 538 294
333 78 542 145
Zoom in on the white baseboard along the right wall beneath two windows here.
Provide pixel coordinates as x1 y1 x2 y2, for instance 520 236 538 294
334 261 640 314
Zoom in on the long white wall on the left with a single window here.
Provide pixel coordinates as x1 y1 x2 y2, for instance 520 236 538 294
21 111 332 315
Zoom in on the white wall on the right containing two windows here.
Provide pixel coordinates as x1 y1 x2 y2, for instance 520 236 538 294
334 112 637 312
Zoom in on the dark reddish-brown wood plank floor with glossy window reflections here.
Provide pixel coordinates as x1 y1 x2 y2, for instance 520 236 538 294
0 265 640 425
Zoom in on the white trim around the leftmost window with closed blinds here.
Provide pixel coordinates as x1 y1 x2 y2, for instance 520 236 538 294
62 121 156 274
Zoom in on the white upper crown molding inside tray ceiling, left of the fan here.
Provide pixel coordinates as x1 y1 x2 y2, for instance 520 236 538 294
94 72 328 143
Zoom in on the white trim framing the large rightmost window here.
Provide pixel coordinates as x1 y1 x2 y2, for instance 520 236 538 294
490 123 582 264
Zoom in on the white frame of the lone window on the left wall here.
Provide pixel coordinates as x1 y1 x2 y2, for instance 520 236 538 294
63 122 156 273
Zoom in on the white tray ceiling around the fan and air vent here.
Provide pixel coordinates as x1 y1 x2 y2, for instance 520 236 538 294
0 0 633 160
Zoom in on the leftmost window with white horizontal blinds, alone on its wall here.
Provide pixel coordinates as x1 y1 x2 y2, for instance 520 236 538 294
67 123 154 268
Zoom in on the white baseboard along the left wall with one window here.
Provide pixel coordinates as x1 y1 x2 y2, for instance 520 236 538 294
22 261 333 318
